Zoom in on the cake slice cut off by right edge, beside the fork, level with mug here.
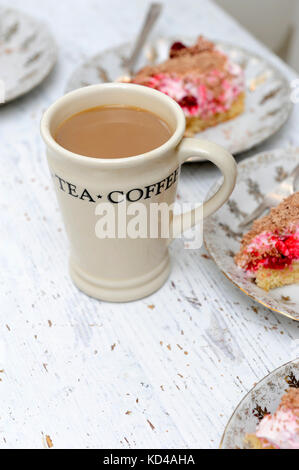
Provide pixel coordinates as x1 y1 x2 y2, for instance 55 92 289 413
235 192 299 291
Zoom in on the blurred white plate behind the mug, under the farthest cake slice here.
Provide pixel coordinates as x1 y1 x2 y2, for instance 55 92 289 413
67 38 292 157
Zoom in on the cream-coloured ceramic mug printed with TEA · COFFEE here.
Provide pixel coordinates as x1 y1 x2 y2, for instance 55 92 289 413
41 83 237 302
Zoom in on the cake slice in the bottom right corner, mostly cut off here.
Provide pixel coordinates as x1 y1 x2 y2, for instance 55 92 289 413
245 388 299 449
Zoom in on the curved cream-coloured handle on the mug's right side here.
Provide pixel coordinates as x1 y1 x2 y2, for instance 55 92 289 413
172 138 237 238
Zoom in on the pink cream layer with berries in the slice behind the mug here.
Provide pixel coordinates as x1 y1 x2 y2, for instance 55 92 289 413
135 63 245 119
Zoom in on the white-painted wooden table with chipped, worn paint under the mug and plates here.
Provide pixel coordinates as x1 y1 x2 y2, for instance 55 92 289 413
0 0 299 449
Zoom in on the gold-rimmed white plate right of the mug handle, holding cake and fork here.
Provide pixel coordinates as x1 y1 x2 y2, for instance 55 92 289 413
204 148 299 320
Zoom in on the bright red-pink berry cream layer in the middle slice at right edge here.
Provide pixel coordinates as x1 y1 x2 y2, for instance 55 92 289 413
242 225 299 272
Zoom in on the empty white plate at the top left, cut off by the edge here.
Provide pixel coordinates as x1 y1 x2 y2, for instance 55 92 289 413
0 6 57 102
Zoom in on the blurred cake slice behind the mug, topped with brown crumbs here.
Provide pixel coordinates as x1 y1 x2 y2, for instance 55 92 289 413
132 36 245 135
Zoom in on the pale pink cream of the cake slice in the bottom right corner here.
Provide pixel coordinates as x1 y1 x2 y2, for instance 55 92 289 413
256 408 299 449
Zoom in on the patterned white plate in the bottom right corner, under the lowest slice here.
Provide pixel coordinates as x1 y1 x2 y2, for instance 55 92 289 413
220 359 299 449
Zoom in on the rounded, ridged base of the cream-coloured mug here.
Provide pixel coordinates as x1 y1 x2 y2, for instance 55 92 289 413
70 255 171 303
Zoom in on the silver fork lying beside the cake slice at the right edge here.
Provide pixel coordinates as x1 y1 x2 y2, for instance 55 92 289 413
239 164 299 230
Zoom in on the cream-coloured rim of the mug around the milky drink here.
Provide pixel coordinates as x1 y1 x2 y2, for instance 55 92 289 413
41 83 186 168
